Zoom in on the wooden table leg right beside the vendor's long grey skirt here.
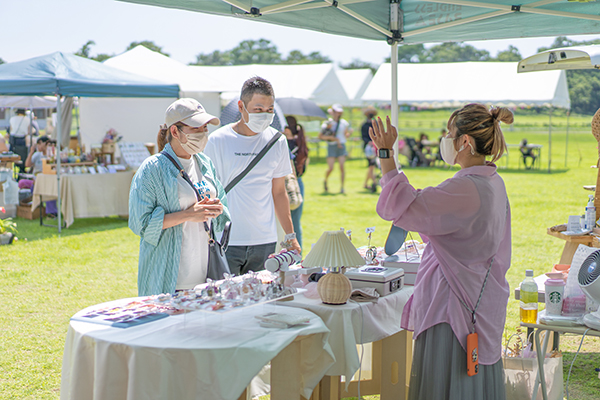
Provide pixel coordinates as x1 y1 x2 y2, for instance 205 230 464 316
380 330 412 400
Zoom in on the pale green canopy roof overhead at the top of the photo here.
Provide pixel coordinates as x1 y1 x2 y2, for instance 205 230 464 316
121 0 600 44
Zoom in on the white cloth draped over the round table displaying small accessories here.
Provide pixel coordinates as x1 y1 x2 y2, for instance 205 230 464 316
60 300 334 400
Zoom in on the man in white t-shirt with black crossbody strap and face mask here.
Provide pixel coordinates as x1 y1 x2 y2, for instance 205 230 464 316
204 77 300 275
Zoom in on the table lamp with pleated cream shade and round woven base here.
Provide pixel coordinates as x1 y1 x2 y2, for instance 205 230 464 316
302 230 365 304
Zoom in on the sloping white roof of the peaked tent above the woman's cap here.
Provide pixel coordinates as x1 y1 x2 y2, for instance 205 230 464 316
104 45 236 92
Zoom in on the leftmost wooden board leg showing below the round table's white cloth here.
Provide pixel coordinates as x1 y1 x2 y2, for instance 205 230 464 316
271 339 300 400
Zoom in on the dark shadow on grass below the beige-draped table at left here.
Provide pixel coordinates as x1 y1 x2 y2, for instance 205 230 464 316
14 217 127 242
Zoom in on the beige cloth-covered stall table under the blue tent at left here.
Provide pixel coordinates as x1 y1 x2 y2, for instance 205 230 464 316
31 171 135 227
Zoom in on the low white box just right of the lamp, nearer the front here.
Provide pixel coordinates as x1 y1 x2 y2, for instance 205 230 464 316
346 265 404 296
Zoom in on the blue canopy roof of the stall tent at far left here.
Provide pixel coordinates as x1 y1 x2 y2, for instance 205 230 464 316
0 52 179 97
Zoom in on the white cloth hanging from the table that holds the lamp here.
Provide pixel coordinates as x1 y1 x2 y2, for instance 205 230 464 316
282 286 413 382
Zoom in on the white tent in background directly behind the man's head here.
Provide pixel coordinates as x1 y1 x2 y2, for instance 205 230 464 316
195 64 348 105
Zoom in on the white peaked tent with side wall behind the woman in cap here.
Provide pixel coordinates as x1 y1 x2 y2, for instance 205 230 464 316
80 46 233 152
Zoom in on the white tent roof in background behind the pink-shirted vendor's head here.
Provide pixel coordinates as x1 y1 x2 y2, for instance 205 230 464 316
363 62 571 108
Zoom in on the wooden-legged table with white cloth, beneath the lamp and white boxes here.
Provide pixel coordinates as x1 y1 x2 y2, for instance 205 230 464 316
281 286 413 400
